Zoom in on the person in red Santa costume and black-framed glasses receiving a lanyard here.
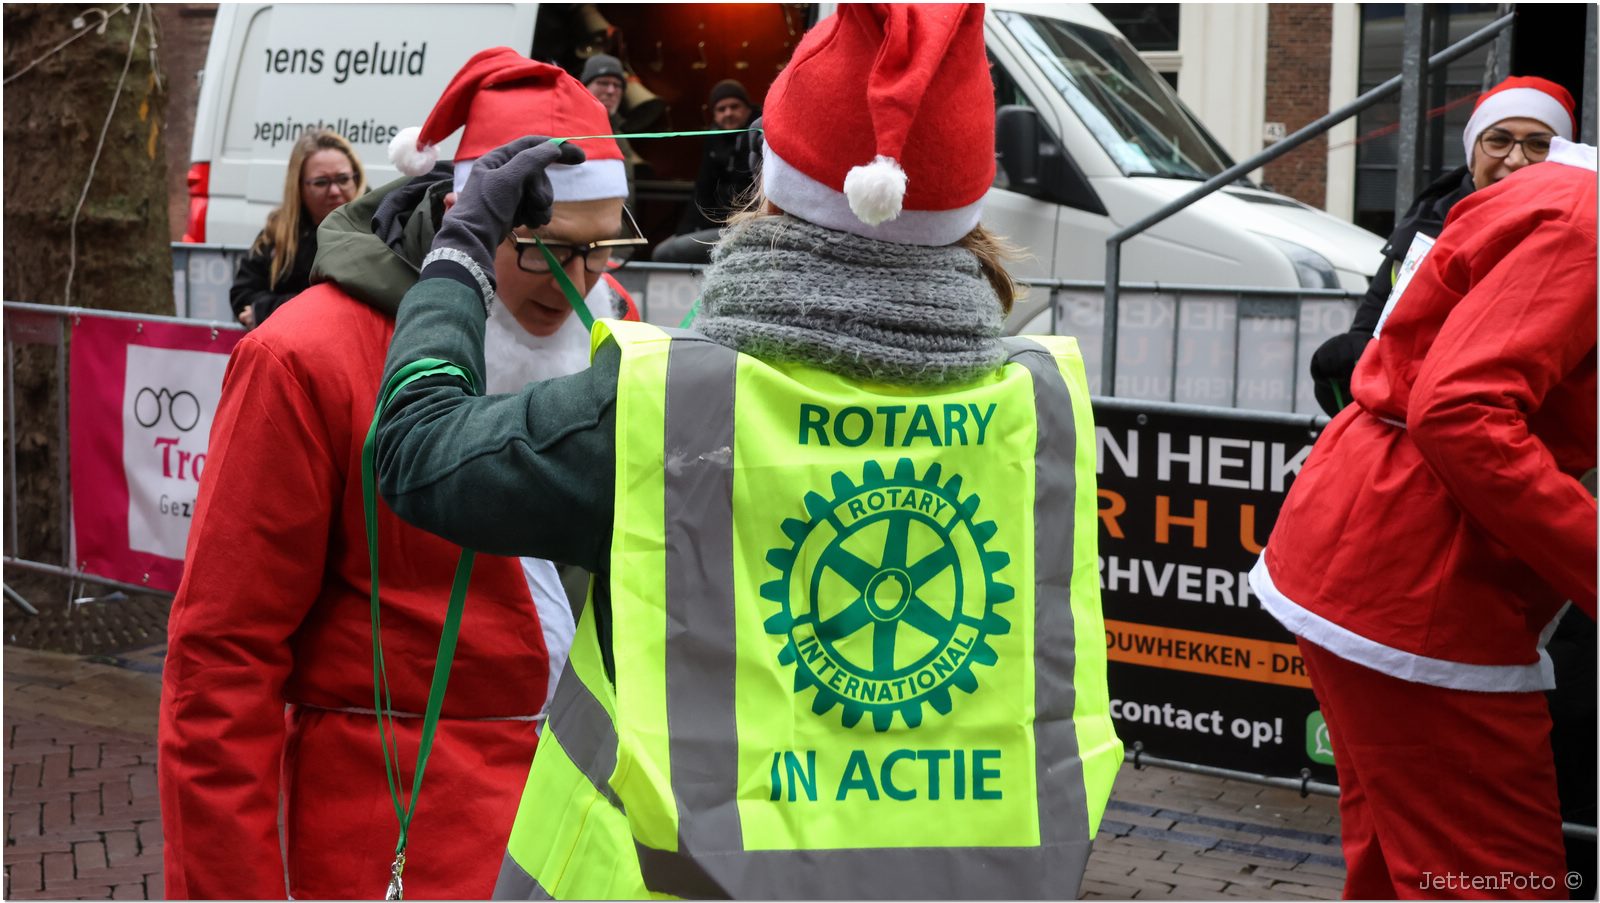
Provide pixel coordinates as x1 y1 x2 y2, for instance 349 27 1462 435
158 48 637 900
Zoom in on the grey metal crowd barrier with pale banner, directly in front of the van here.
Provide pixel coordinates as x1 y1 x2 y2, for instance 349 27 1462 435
173 243 1360 415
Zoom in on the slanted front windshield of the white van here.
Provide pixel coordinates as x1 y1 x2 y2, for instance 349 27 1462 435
997 11 1232 179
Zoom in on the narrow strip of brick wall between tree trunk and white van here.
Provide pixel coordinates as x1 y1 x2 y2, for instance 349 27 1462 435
155 3 216 242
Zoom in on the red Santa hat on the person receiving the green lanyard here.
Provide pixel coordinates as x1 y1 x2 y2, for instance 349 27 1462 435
389 46 627 200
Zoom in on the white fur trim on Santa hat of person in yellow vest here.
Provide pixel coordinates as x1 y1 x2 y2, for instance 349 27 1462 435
762 142 984 248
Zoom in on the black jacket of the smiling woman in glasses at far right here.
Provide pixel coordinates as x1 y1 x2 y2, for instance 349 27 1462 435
1310 167 1472 416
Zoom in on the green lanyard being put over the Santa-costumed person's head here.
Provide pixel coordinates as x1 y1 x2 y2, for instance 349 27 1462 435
362 130 742 900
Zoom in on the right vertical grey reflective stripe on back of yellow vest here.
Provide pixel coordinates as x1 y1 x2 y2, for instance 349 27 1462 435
1005 338 1090 851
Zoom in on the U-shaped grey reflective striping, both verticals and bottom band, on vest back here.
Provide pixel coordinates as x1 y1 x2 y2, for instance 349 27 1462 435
635 330 1090 898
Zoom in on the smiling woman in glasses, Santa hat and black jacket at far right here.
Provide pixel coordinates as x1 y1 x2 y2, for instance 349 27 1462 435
1310 75 1574 416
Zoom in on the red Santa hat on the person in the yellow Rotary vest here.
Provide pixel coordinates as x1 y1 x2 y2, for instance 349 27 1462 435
762 3 995 245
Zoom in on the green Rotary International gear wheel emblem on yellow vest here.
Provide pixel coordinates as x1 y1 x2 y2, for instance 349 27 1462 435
762 458 1014 730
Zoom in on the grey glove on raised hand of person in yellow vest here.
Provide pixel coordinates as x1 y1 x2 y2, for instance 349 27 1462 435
424 136 586 304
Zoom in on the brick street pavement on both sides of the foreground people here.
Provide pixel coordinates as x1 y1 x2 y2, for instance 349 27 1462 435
3 645 1344 900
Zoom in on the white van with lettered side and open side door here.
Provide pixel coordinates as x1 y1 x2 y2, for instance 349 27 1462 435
175 3 1382 302
